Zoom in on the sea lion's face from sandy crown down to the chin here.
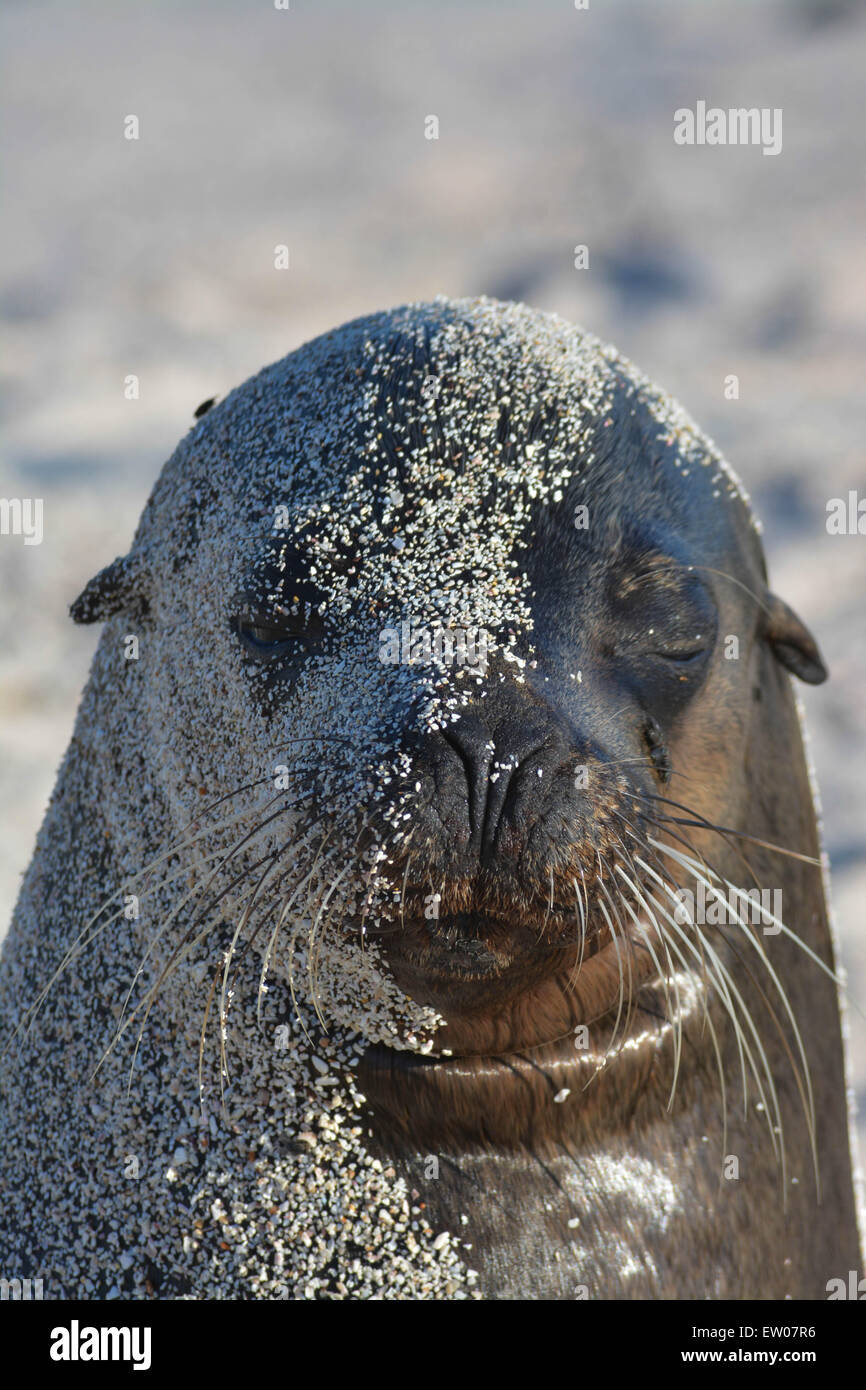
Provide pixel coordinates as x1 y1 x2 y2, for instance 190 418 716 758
79 293 828 1051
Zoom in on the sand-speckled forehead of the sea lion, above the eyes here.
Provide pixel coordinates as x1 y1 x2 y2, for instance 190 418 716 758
140 299 744 621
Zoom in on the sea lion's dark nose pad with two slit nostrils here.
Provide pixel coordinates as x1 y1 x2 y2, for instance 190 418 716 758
443 712 562 860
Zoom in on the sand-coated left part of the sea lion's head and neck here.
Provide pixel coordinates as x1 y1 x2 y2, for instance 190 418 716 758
0 299 746 1298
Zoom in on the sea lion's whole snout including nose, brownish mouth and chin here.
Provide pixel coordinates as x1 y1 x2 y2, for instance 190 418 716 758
373 664 656 1028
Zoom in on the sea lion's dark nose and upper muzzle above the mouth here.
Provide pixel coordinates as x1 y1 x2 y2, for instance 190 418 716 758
383 683 614 922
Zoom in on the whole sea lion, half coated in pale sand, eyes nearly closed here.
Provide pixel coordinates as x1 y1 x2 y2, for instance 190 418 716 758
0 299 859 1298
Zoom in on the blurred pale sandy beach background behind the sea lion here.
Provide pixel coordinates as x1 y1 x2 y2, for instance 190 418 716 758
0 0 866 1144
